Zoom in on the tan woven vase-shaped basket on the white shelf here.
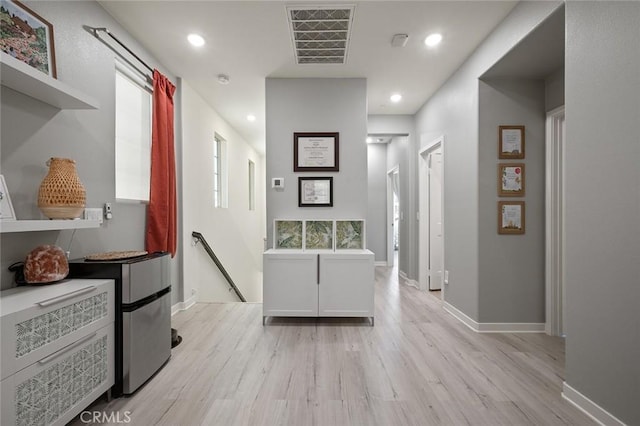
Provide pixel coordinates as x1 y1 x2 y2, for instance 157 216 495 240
38 158 87 219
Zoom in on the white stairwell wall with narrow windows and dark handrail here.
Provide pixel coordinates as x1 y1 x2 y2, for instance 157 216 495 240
181 81 265 302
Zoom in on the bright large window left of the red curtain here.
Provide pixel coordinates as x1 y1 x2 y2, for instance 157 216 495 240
116 61 152 201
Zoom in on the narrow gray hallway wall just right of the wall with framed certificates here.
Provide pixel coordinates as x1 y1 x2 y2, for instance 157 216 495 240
367 143 387 262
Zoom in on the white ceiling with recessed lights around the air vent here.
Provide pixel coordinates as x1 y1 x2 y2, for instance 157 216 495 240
101 0 517 153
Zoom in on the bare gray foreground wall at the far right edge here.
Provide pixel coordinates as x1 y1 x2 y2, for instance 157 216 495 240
565 1 640 425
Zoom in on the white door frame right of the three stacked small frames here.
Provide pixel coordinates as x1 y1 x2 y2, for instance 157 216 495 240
545 105 566 336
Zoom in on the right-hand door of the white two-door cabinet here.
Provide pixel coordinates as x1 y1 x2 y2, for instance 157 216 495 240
318 251 375 317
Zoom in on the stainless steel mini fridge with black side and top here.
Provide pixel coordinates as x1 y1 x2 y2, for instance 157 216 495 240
69 253 171 396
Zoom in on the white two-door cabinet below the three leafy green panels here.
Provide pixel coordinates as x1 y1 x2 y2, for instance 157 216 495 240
262 250 375 323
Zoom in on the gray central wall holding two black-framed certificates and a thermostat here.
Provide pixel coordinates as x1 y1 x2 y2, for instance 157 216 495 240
266 78 367 247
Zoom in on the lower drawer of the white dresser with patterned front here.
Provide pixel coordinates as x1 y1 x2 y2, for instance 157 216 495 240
1 324 114 426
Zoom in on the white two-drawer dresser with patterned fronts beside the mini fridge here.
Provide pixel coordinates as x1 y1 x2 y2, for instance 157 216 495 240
0 279 115 426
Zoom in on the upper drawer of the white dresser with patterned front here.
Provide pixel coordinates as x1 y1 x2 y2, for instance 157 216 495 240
0 280 115 379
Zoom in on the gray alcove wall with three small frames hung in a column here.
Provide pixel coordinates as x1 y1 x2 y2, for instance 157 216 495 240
478 78 545 323
